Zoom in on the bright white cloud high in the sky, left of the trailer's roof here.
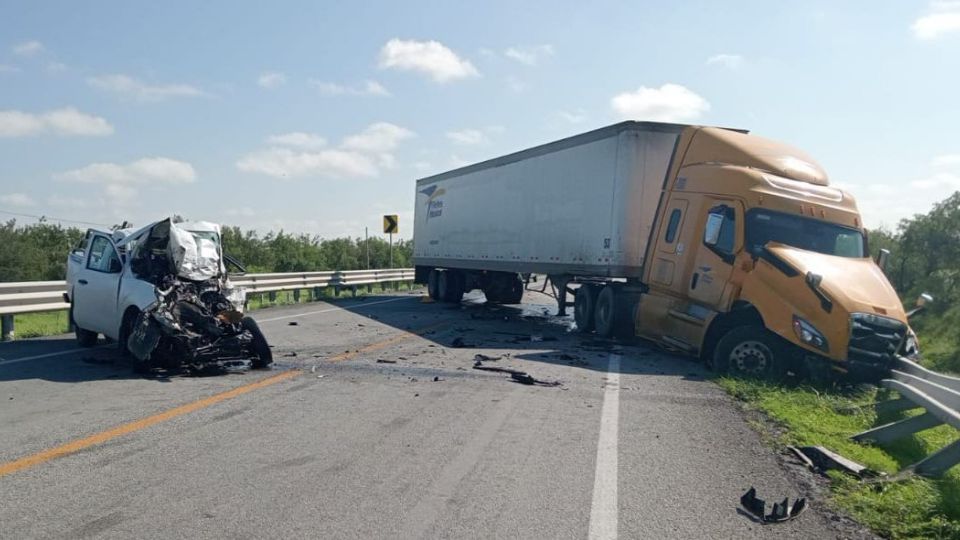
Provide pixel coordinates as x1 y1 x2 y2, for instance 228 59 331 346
380 38 480 83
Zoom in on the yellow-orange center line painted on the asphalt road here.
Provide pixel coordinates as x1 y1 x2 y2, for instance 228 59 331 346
0 321 448 477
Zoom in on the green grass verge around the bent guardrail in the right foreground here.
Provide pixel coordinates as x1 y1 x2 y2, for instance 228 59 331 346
717 377 960 539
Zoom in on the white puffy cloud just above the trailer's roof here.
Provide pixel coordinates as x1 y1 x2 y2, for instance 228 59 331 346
610 83 710 122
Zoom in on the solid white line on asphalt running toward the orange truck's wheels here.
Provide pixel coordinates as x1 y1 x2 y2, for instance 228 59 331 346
589 354 620 540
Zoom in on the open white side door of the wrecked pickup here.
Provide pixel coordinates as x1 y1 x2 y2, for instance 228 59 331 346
72 234 123 337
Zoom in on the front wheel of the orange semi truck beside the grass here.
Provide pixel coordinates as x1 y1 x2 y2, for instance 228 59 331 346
713 326 784 379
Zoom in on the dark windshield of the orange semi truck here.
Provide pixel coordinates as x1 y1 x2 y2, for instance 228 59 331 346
746 209 864 258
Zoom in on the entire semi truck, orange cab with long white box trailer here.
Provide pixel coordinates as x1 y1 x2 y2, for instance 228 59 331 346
413 121 930 379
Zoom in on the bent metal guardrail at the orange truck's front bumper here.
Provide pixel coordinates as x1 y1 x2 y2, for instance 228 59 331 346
853 358 960 478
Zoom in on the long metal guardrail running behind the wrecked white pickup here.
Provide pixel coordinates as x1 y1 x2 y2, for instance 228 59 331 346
0 268 414 337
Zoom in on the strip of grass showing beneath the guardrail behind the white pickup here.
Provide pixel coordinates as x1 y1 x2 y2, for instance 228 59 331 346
7 283 419 339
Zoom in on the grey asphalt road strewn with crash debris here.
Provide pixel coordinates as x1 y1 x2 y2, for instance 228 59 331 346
0 293 872 538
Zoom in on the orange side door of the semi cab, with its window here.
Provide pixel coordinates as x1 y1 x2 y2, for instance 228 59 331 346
687 200 743 311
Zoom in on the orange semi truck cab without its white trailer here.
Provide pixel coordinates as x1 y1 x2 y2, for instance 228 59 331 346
635 126 918 377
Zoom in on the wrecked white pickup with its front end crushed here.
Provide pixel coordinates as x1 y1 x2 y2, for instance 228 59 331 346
66 217 273 371
